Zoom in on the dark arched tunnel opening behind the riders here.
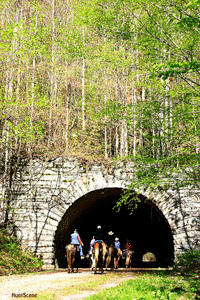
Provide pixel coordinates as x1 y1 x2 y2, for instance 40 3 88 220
54 188 174 268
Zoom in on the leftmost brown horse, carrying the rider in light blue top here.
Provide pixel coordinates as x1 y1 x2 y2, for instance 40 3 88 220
66 244 80 273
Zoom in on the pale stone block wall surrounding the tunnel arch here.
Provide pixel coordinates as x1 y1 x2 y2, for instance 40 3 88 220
0 159 200 267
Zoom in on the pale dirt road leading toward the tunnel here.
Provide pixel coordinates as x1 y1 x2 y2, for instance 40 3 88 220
0 269 136 300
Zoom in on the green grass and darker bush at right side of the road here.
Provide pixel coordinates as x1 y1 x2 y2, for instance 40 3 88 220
87 250 200 300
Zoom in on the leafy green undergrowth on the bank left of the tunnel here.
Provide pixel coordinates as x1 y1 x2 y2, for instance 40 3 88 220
0 230 43 275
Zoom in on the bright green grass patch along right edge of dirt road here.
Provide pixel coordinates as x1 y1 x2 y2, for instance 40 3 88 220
87 274 200 300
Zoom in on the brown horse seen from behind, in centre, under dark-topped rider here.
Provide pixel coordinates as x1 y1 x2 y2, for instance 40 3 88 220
93 242 106 274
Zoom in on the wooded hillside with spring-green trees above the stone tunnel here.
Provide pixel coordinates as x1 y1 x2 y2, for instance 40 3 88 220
0 0 200 221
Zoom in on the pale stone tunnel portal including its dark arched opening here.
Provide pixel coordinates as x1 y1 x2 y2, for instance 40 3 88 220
10 159 200 268
